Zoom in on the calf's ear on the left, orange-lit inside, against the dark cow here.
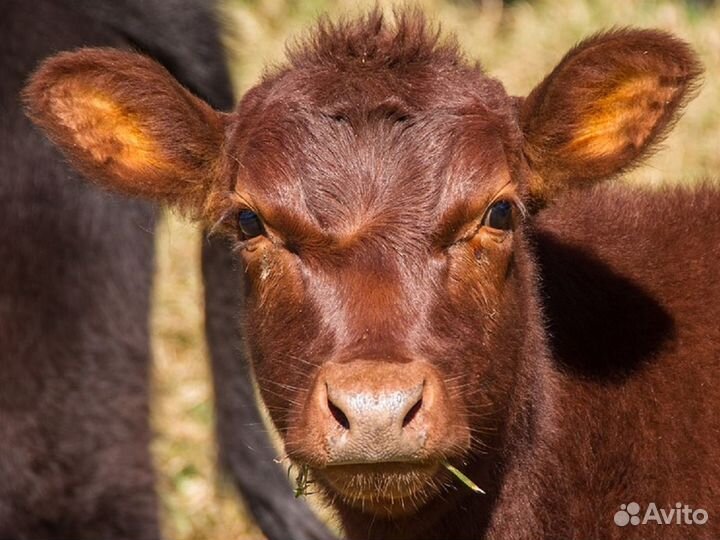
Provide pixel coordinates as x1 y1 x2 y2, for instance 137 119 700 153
23 49 225 211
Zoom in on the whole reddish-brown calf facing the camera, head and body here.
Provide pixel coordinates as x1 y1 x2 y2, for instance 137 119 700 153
25 9 720 539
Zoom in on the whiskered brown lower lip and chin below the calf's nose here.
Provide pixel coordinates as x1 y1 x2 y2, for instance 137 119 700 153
313 461 443 517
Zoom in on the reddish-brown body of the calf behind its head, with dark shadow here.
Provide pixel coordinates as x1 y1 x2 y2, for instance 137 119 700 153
524 184 720 538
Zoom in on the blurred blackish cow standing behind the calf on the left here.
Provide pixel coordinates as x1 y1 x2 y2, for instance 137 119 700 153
0 0 327 540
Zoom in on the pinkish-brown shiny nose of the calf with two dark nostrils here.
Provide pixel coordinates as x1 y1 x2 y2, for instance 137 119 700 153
308 360 448 464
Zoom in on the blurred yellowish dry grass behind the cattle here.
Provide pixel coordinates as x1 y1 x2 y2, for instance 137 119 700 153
152 0 720 540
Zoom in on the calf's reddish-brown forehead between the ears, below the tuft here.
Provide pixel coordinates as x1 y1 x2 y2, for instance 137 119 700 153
236 78 515 240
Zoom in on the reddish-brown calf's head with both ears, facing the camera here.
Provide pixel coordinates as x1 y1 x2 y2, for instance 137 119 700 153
24 13 700 518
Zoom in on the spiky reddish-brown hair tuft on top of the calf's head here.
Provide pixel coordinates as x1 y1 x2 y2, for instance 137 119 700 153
287 7 466 75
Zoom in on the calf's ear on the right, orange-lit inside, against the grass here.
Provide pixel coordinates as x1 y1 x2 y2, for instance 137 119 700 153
520 30 702 201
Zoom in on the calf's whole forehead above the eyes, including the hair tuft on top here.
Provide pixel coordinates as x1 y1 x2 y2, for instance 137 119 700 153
228 11 520 253
